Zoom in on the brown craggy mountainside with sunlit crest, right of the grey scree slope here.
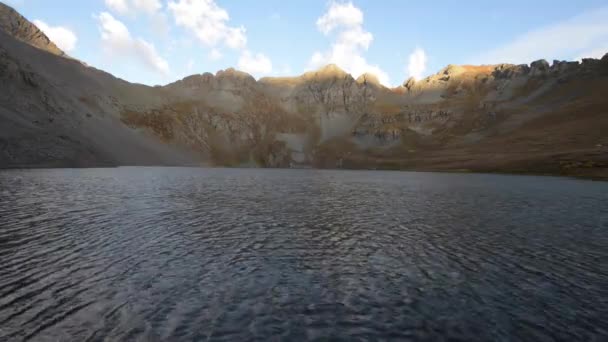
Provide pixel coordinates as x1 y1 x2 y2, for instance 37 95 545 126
124 57 608 176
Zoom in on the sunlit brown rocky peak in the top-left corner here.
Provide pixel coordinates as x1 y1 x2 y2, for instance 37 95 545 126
0 2 65 56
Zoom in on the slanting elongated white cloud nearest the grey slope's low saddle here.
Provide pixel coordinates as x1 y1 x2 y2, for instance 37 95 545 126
96 12 169 76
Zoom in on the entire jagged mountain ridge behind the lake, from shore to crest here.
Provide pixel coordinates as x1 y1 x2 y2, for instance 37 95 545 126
0 4 608 177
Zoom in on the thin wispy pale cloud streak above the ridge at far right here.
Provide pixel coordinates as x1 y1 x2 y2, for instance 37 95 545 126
472 7 608 64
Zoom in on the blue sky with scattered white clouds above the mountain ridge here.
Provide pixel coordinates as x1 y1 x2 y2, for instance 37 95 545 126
7 0 608 86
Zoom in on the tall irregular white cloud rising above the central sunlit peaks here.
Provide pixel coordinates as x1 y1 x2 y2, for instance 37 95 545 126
309 2 389 85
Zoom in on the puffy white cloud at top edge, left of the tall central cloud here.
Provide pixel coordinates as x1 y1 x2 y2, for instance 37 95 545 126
168 0 247 49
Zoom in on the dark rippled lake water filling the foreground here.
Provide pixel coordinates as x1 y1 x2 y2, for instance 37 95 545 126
0 168 608 341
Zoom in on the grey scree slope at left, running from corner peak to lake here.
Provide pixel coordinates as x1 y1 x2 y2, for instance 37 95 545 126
0 5 200 167
